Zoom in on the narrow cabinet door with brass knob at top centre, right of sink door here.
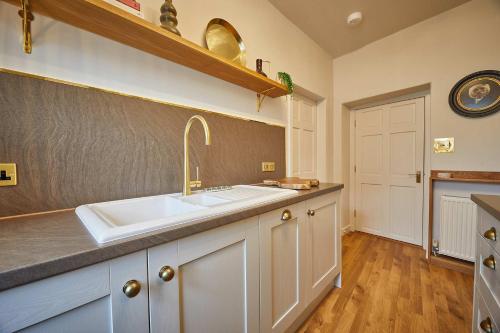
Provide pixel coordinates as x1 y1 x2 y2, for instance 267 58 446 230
260 202 306 333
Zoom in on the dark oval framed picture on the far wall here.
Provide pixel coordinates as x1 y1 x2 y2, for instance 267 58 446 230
448 70 500 118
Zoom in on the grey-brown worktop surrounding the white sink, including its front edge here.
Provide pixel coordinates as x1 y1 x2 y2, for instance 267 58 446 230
0 183 344 291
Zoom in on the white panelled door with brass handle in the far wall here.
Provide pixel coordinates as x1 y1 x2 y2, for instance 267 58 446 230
356 98 424 245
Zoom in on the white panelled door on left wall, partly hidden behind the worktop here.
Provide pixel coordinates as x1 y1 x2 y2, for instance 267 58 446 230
288 94 317 178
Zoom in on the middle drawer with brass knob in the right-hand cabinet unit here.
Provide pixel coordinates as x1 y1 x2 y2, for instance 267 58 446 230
476 233 500 304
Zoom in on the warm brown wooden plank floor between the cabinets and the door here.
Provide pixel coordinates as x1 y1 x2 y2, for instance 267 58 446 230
299 232 473 333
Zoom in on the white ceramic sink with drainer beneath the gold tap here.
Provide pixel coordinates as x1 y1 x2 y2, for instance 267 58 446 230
76 185 297 243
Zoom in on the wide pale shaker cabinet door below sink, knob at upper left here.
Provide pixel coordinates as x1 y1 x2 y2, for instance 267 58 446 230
149 218 259 333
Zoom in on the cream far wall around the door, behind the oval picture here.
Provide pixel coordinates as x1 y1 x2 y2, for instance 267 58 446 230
333 0 500 236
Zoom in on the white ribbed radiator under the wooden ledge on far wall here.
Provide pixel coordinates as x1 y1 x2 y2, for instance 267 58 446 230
439 195 477 262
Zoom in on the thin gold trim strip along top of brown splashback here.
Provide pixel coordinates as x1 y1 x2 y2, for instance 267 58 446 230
0 67 286 128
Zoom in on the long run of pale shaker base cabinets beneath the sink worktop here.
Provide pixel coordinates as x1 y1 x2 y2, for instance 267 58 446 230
0 187 341 333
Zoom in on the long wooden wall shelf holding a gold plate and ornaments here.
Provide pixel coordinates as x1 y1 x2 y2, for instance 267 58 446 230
2 0 288 97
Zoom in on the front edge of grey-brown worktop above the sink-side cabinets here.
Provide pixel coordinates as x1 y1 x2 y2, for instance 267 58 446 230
0 184 344 292
